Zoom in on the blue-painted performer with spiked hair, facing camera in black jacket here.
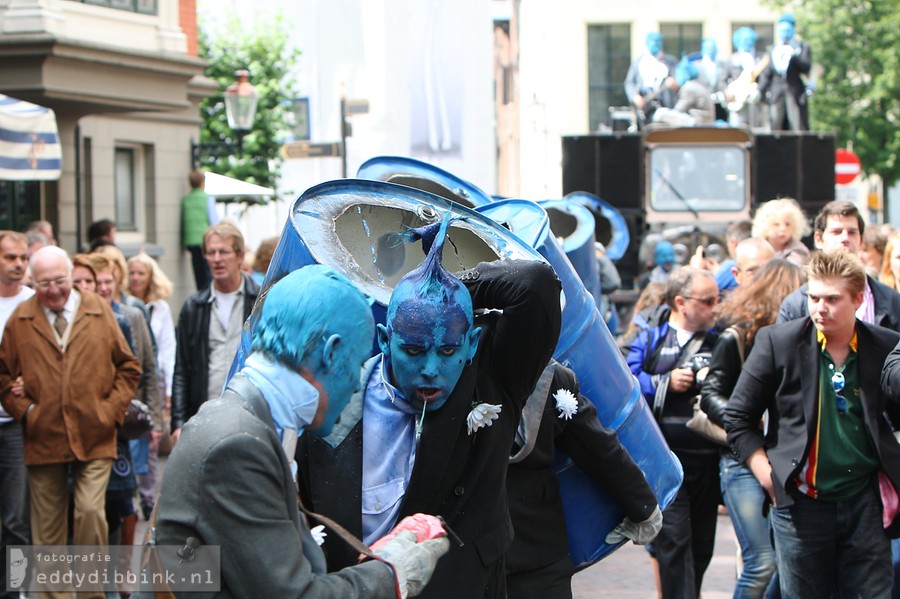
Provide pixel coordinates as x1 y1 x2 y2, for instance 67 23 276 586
297 214 561 599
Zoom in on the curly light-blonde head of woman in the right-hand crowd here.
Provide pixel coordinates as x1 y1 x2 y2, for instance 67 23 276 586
750 198 810 266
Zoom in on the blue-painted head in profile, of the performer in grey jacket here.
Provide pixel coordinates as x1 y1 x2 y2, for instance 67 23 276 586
251 264 375 436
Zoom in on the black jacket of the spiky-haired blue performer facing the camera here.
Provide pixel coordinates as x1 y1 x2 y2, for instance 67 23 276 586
297 261 560 599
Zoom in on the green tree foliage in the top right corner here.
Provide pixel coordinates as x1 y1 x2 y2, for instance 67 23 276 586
789 0 900 186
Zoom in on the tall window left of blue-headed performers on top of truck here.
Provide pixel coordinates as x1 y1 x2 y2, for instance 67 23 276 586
587 23 631 131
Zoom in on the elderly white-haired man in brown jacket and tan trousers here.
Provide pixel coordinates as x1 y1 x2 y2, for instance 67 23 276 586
0 246 141 596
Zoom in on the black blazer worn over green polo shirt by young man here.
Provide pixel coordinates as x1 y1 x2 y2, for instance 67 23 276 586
725 318 900 532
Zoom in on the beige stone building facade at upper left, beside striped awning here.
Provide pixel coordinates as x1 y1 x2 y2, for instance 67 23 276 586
0 0 216 309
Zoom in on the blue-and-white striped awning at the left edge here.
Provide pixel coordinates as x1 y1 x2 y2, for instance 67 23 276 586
0 94 62 181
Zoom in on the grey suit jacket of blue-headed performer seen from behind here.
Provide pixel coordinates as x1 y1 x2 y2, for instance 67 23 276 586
149 374 396 599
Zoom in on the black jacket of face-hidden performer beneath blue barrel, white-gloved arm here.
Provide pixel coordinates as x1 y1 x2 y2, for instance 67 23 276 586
506 361 657 576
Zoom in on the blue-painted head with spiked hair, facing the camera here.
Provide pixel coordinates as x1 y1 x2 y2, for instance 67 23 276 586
378 214 481 411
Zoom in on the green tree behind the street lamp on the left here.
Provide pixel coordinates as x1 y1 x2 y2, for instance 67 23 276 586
199 14 300 195
